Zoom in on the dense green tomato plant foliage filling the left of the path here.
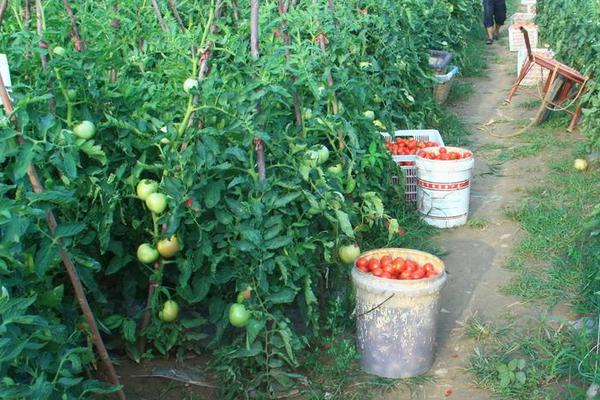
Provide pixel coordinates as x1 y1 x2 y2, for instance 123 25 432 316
0 0 479 398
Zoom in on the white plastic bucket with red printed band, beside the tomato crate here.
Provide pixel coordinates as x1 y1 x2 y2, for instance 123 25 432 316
415 147 475 228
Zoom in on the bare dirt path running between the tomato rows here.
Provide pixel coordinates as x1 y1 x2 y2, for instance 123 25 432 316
384 26 545 400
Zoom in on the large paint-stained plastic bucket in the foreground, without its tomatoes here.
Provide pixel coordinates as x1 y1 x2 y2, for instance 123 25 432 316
352 249 447 378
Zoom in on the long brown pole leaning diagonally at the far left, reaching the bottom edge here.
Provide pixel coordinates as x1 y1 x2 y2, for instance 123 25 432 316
0 73 125 400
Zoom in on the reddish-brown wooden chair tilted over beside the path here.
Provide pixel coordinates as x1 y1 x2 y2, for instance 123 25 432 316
506 27 590 132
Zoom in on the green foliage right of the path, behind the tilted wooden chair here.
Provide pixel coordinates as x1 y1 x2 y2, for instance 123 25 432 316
537 0 600 149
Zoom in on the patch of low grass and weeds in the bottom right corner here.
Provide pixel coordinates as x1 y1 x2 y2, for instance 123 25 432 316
467 318 600 400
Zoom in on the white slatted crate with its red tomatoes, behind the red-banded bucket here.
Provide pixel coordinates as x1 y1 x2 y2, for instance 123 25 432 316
381 129 444 205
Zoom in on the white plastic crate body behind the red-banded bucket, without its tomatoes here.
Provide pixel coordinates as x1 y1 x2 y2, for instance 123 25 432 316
380 129 444 205
